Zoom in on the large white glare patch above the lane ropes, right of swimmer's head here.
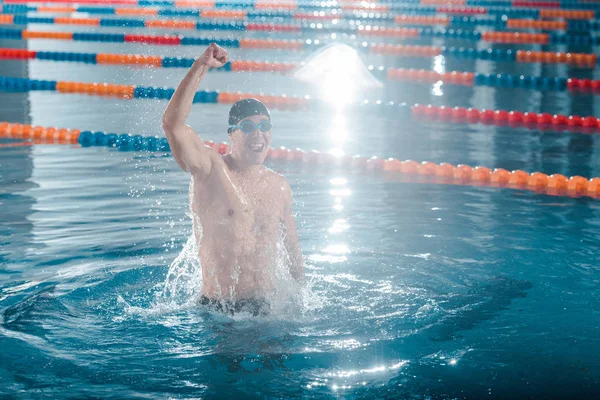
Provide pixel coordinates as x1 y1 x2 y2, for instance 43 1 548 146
292 43 382 108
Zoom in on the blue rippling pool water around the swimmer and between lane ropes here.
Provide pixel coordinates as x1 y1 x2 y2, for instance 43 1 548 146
0 4 600 399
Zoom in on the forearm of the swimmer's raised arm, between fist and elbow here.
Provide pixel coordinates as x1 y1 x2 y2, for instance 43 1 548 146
163 59 209 132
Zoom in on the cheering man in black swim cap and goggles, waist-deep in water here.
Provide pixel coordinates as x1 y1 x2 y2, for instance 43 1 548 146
162 43 304 313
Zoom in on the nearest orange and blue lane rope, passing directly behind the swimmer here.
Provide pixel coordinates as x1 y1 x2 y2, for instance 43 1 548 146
0 122 600 198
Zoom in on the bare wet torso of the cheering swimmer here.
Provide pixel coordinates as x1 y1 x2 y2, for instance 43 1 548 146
190 153 284 300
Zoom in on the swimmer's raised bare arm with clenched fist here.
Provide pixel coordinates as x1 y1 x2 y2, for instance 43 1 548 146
162 43 227 176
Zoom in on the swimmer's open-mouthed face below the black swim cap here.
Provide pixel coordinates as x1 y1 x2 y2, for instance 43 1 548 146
230 115 271 165
